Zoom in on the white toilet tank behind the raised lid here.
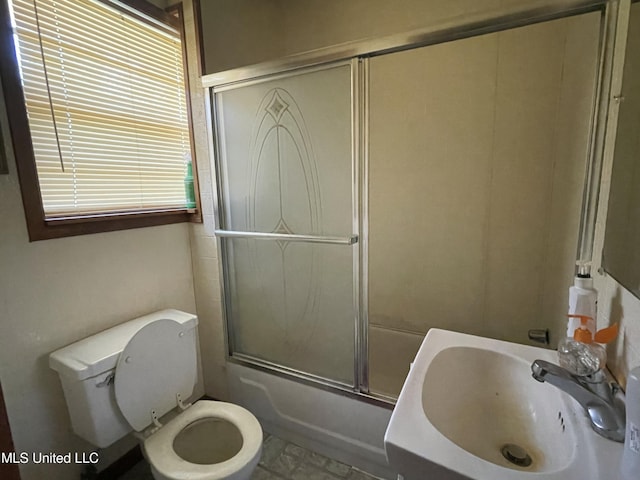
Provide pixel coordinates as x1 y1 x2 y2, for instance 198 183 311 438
49 310 198 448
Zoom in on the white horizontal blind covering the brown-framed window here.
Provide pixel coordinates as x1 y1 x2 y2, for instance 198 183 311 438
11 0 190 218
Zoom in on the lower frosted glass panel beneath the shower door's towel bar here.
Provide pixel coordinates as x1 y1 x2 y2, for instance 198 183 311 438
223 239 355 385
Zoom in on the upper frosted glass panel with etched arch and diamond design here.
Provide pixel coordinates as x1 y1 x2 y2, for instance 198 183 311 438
216 65 352 235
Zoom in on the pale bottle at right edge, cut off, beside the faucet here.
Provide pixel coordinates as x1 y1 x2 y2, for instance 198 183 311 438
620 367 640 480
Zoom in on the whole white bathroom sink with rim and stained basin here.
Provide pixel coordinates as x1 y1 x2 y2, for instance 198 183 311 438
385 329 622 480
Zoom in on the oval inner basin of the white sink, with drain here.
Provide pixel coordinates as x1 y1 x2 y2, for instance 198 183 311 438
422 346 576 472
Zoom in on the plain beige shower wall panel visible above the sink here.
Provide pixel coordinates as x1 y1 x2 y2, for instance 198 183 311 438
368 13 600 395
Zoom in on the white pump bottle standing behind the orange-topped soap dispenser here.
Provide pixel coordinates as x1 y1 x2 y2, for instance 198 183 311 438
567 261 598 338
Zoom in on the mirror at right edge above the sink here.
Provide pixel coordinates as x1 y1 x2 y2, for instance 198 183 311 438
602 2 640 298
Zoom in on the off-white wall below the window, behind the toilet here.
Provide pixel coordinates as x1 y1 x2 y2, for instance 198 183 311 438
0 84 201 480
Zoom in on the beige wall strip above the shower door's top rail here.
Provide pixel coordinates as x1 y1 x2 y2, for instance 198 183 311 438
200 0 604 73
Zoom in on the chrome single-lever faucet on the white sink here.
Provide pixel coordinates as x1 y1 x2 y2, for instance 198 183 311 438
531 360 625 442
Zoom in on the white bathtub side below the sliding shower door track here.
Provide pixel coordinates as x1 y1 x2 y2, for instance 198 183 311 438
227 363 397 480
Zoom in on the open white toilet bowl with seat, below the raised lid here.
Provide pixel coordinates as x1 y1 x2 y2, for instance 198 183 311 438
143 400 262 480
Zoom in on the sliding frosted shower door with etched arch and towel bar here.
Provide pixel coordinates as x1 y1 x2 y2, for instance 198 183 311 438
214 62 359 387
